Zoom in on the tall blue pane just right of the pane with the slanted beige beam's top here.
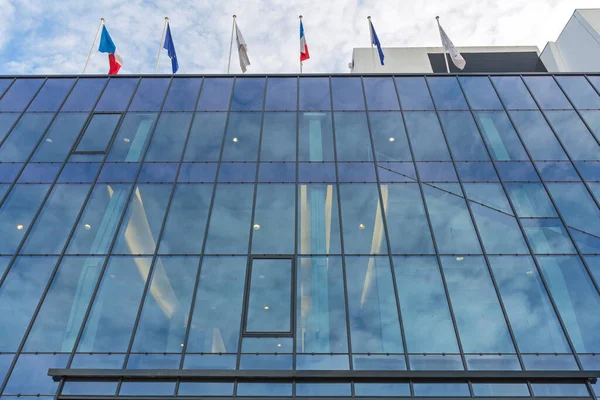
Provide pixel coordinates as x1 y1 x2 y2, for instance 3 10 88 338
159 184 213 254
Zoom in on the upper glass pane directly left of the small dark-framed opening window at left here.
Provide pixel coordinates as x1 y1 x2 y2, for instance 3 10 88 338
31 113 88 162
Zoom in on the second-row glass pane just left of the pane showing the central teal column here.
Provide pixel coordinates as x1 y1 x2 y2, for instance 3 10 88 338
260 112 297 161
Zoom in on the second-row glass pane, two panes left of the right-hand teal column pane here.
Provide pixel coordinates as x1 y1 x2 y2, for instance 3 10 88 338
404 112 450 161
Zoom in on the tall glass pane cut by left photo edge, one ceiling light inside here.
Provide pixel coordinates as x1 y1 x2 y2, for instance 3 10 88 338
0 185 50 254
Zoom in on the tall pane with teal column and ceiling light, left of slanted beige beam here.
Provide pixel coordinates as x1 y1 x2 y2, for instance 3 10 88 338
67 184 131 254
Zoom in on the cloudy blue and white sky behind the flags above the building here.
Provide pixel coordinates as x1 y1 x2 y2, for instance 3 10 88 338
0 0 600 75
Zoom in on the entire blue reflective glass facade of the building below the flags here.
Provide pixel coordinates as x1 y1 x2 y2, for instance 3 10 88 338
0 74 600 399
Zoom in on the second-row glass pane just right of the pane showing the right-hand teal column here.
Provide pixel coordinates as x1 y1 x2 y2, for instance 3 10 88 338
510 111 569 160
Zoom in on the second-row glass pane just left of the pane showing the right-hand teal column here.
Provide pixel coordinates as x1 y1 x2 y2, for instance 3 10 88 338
439 112 489 161
